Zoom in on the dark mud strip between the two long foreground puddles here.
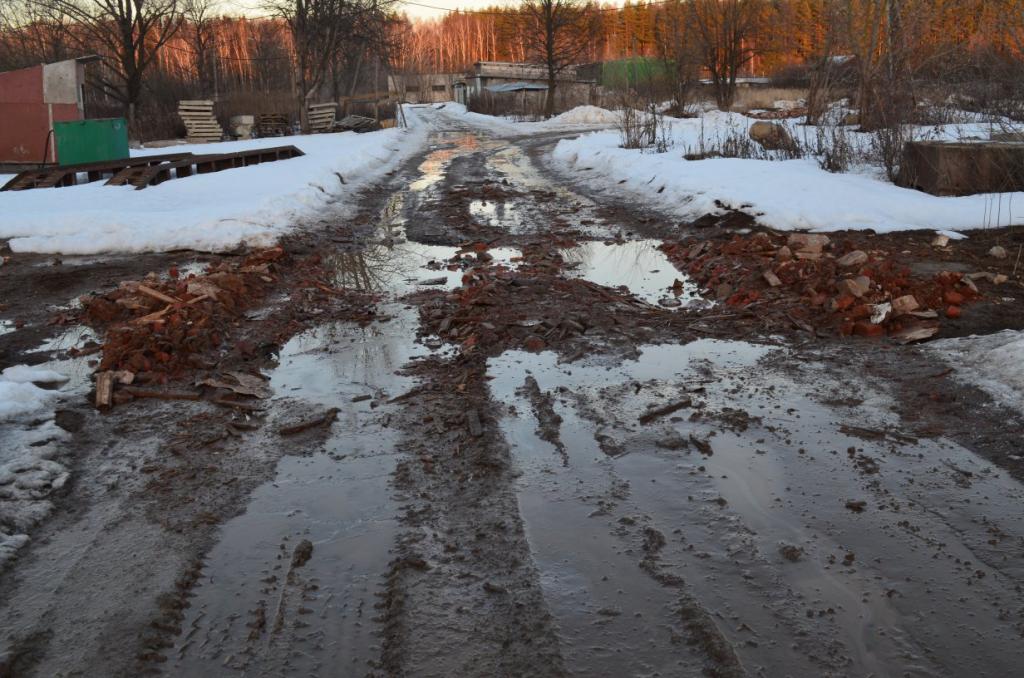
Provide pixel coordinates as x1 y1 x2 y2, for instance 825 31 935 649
381 357 568 676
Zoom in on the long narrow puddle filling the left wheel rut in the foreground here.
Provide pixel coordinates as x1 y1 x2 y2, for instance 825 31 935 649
170 307 434 676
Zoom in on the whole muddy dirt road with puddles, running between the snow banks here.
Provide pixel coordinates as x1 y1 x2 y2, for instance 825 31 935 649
0 111 1024 677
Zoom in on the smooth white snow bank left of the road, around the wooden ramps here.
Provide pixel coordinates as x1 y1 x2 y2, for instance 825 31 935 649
0 115 426 254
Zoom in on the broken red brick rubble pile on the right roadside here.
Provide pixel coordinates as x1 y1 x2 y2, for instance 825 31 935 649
662 231 999 341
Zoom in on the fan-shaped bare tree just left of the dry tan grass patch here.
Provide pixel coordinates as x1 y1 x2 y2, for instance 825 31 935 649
690 0 762 111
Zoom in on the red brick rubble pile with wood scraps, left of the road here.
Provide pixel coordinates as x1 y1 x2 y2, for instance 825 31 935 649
81 247 285 380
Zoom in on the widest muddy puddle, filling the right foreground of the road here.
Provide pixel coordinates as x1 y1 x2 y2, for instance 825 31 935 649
488 341 1024 676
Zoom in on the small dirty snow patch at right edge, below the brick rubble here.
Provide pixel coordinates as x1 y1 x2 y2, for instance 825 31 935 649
931 330 1024 413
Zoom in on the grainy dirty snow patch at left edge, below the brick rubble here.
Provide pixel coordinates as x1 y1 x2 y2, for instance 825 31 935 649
0 365 69 566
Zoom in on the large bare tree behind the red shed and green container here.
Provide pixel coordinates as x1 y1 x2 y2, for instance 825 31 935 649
36 0 181 126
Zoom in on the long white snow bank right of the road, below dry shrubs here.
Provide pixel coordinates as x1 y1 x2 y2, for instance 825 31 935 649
554 112 1024 232
